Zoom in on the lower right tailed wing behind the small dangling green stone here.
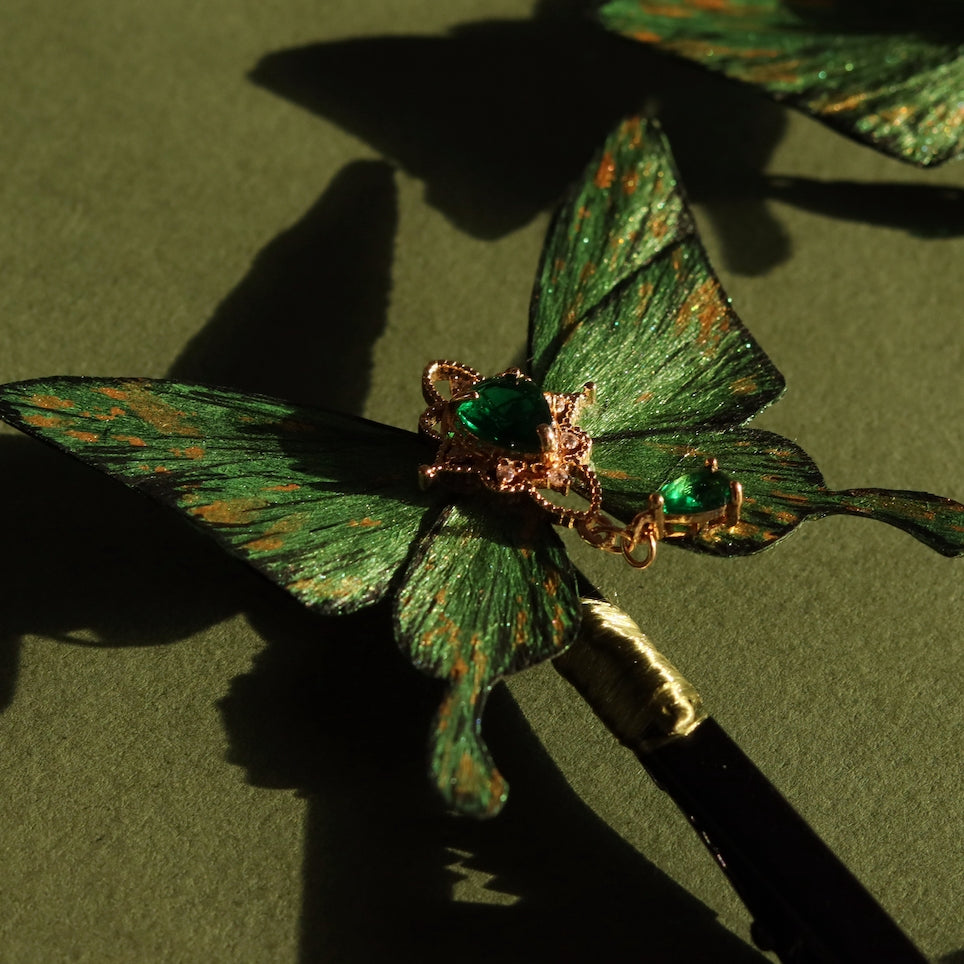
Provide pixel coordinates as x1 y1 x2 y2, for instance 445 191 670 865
593 427 964 556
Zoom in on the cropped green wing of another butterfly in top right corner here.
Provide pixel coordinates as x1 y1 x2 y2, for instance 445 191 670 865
599 0 964 166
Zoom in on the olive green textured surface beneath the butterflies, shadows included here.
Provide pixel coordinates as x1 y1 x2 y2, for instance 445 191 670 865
0 0 964 962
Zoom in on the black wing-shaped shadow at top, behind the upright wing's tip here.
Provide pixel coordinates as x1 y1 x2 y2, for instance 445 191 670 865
250 0 790 274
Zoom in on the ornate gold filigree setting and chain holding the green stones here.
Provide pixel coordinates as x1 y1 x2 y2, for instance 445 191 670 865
418 360 743 569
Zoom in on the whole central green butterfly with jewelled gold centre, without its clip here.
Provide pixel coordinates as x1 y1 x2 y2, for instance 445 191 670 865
0 119 964 816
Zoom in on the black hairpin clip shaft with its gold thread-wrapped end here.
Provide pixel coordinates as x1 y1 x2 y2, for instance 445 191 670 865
553 599 925 964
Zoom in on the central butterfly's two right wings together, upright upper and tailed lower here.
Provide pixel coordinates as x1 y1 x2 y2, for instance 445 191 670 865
530 120 964 555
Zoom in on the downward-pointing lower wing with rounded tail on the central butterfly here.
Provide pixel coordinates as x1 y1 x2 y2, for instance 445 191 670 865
396 497 580 817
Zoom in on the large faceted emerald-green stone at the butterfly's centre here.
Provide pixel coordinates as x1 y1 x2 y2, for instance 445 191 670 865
455 375 552 452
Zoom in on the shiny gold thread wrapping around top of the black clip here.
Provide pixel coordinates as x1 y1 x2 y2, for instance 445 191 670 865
553 598 707 752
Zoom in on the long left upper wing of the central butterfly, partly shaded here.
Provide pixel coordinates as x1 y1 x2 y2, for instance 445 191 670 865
0 378 431 613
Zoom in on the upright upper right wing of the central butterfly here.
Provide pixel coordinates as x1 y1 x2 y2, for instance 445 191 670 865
530 118 783 438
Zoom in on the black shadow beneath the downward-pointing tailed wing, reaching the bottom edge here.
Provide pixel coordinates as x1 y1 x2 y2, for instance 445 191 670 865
221 600 764 964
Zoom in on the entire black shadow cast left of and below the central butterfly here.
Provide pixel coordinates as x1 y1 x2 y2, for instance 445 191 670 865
0 156 761 962
